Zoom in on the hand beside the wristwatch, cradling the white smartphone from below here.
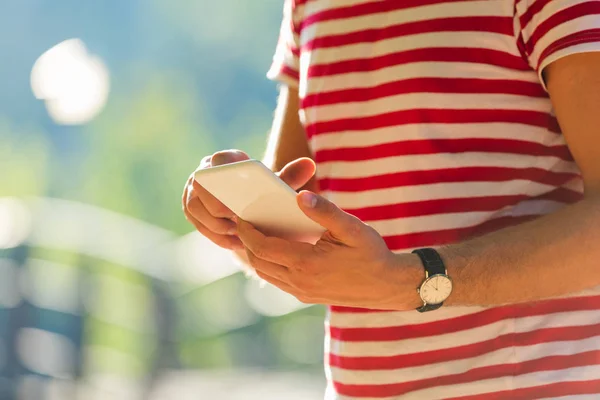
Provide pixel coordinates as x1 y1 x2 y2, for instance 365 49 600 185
238 191 423 309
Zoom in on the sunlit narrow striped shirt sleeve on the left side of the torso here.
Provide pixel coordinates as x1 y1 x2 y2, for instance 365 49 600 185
267 0 300 88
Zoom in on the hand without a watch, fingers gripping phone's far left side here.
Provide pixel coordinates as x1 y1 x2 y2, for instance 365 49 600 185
182 150 315 250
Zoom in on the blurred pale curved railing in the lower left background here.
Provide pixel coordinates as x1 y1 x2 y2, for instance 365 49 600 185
0 198 322 399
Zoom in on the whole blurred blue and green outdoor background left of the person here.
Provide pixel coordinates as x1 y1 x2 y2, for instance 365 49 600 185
0 0 324 400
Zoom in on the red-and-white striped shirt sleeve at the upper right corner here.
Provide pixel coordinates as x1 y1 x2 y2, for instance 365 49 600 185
515 0 600 89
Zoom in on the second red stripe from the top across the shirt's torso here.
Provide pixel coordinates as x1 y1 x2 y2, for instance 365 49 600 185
301 16 513 51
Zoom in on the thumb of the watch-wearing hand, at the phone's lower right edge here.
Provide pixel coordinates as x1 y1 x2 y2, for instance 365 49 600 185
297 190 368 246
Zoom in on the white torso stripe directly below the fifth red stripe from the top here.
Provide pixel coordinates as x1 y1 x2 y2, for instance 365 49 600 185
311 122 565 151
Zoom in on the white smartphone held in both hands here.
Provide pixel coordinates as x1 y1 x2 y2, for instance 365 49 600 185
194 160 325 243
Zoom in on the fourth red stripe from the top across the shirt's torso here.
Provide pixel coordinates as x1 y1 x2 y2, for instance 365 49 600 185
302 78 547 108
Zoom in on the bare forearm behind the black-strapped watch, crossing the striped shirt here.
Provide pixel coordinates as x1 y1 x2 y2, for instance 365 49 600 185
440 195 600 306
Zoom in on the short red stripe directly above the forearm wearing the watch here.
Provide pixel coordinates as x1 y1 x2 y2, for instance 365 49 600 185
383 215 539 251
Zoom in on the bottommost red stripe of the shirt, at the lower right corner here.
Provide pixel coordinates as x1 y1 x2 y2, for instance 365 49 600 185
446 379 600 400
